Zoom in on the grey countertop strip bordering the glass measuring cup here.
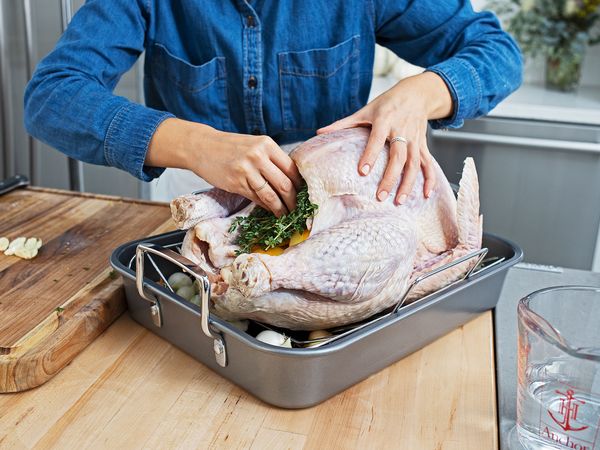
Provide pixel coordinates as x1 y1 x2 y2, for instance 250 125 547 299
494 264 600 450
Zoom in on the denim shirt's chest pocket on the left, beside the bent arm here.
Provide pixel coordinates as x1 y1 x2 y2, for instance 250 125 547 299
149 44 231 130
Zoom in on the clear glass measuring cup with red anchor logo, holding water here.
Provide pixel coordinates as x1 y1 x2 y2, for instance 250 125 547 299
510 286 600 450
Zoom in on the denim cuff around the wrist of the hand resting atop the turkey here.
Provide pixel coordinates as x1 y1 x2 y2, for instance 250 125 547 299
427 57 482 128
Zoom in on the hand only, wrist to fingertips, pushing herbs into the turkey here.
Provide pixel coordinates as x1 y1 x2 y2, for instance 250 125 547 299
190 130 302 217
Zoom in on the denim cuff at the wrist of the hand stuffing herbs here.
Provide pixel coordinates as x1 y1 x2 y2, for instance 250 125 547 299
104 103 175 181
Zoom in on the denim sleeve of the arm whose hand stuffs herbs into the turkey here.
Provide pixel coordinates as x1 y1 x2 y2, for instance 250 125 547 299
24 0 174 181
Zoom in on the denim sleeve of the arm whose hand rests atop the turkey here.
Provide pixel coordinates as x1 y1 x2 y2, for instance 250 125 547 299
376 0 522 128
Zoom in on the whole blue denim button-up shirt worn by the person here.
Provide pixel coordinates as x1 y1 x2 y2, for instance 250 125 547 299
25 0 522 181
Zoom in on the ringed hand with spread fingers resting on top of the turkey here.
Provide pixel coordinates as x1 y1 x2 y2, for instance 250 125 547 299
317 72 452 205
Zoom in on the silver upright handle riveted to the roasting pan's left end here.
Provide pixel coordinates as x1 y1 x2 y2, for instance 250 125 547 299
135 243 227 367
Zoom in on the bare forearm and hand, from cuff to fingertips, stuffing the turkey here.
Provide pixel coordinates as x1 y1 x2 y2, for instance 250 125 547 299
145 119 302 216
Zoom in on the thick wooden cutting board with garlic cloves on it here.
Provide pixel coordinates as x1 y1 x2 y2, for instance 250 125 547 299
0 188 175 392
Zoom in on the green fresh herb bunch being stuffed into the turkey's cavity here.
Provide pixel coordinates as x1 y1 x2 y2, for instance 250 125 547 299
229 183 318 256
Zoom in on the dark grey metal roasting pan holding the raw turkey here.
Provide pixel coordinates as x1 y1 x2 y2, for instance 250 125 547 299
111 231 523 408
